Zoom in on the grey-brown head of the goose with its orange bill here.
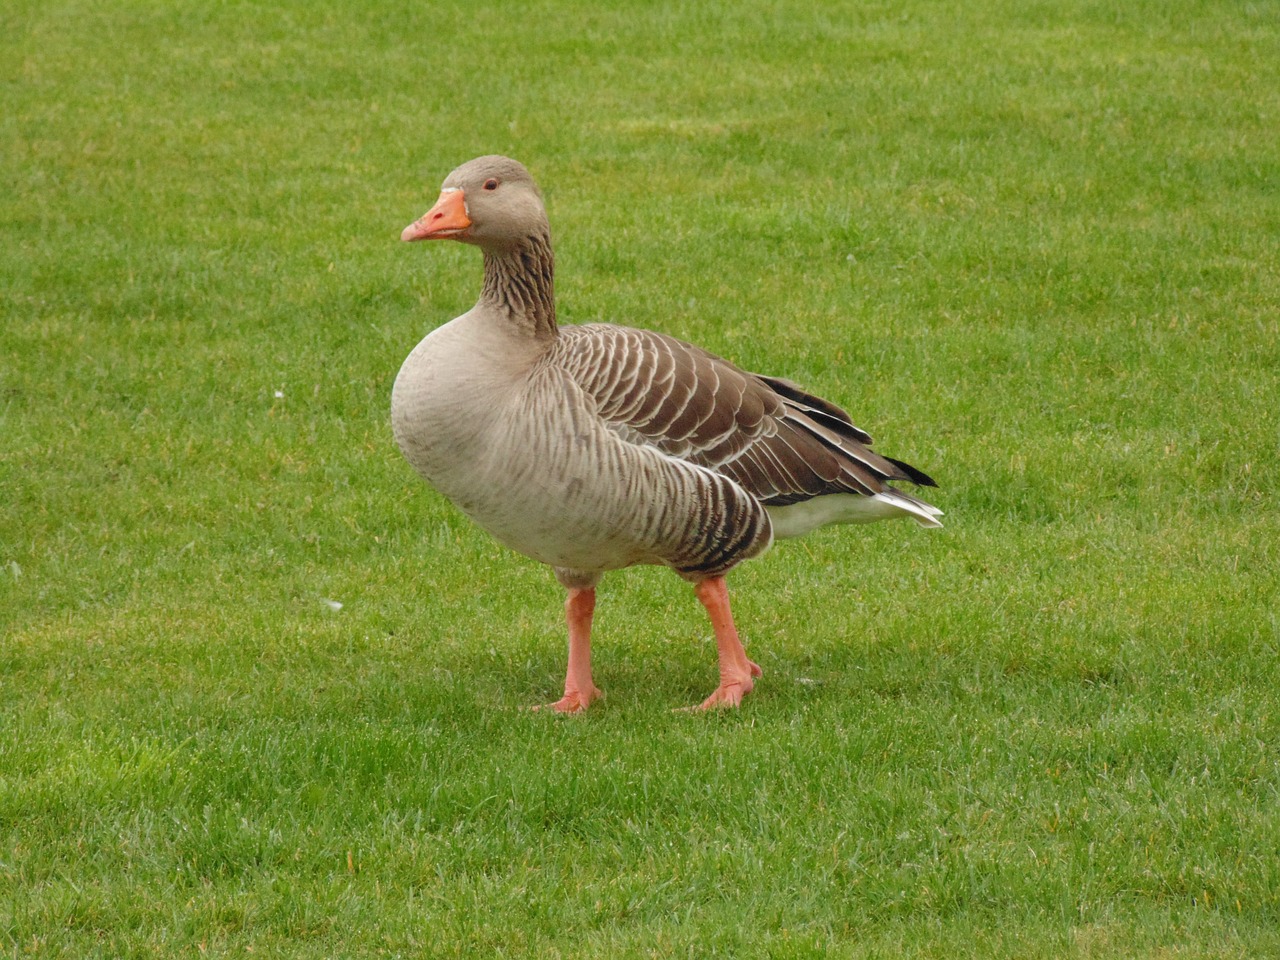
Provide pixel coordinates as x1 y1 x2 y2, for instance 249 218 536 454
401 155 549 253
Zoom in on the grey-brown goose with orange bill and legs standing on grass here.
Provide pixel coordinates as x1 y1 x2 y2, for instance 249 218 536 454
392 156 941 713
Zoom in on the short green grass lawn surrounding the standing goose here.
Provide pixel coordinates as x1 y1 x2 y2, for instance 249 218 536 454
0 0 1280 957
